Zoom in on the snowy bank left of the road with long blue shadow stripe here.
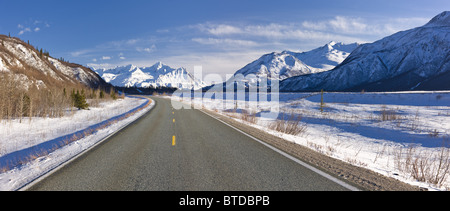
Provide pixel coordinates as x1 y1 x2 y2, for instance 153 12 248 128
0 97 154 190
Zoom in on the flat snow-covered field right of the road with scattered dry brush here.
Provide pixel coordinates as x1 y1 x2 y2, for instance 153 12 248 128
173 92 450 190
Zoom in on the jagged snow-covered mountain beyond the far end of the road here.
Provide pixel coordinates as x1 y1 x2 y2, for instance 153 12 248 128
95 62 206 89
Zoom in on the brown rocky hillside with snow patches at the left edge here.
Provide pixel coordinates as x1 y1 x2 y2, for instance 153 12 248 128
0 35 109 89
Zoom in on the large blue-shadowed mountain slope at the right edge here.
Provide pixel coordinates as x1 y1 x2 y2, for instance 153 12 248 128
280 11 450 91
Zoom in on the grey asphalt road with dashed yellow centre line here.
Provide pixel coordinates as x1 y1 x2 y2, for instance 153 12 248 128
29 98 355 191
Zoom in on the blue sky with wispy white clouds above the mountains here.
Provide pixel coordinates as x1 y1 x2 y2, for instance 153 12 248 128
0 0 450 75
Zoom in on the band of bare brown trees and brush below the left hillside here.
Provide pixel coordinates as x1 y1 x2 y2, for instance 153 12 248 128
0 73 117 122
